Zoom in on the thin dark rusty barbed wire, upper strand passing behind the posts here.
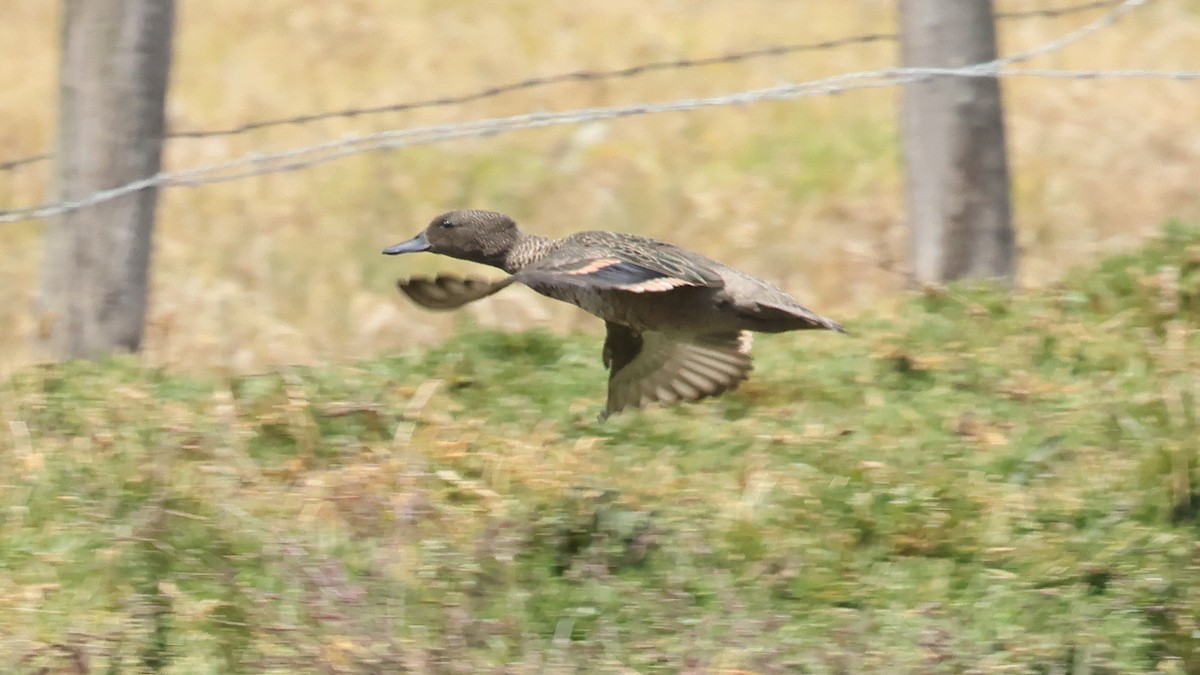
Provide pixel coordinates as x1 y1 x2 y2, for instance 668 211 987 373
0 0 1121 173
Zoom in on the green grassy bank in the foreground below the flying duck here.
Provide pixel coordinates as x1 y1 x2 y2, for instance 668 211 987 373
0 226 1200 673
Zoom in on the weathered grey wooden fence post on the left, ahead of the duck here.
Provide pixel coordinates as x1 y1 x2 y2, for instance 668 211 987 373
40 0 175 358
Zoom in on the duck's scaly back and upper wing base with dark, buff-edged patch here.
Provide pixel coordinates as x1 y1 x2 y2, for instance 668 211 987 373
515 232 725 293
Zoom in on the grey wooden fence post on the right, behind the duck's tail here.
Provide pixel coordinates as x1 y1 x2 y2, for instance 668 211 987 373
900 0 1016 282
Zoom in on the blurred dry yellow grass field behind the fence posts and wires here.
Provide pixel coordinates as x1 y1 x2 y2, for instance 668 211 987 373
0 0 1200 374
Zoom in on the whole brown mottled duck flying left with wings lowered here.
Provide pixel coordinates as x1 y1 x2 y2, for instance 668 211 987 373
384 210 845 416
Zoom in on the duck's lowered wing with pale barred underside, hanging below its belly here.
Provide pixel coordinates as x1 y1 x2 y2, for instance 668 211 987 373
604 322 752 417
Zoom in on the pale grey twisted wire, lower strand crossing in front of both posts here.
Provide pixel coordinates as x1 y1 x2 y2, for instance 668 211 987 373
0 0 1180 222
